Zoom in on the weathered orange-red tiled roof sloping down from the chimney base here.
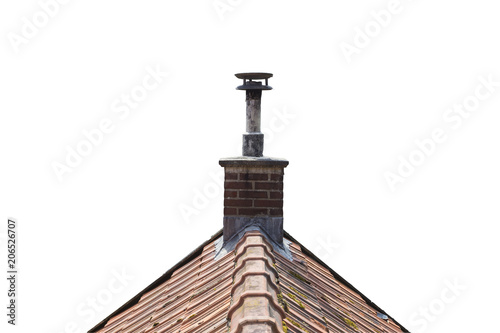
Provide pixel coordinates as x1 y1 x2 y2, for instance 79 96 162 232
89 230 408 333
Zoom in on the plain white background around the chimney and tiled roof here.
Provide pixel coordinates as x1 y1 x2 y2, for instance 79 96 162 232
0 0 500 333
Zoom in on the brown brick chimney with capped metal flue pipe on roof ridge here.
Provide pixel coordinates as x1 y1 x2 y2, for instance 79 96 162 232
219 73 288 244
